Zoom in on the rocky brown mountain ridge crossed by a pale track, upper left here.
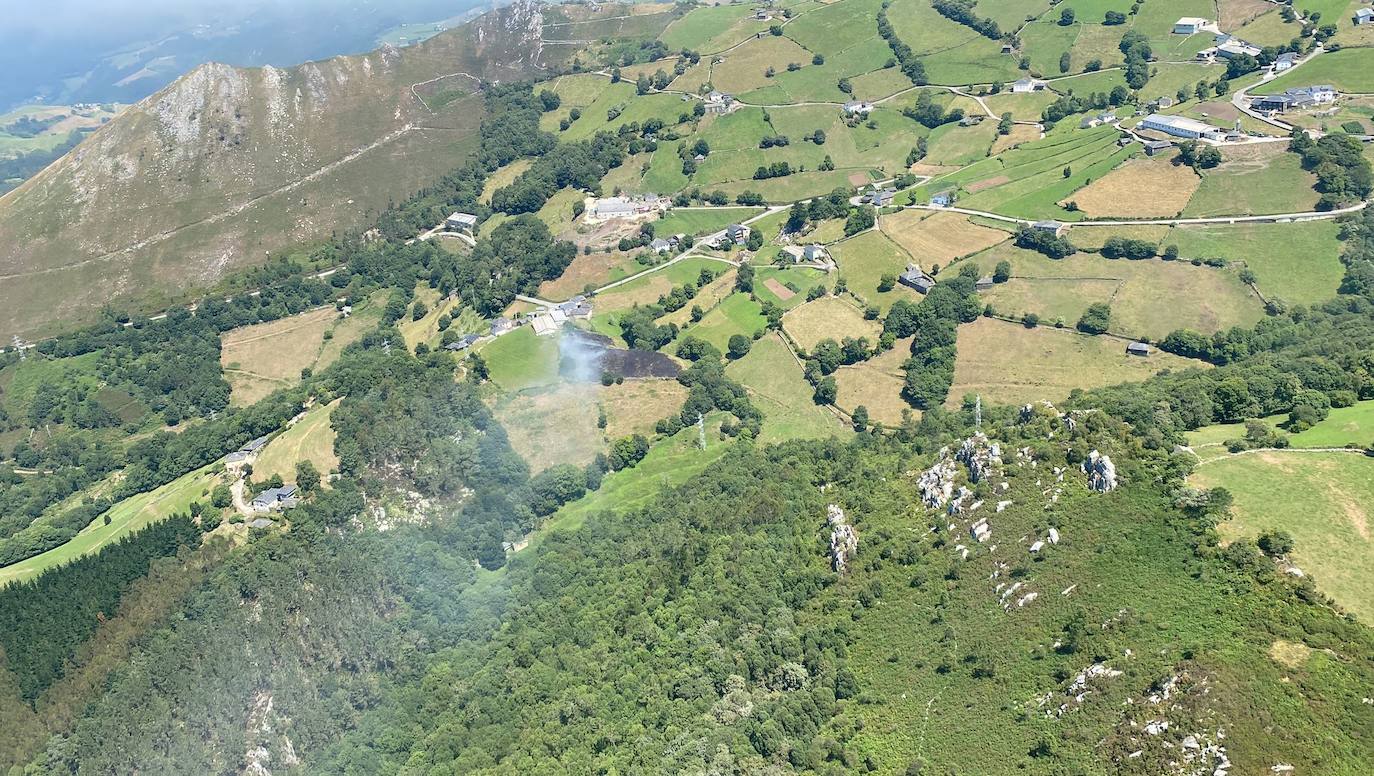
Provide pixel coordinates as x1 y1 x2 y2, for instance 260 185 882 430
0 4 557 341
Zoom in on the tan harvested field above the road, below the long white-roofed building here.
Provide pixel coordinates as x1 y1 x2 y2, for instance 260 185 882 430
1059 157 1202 218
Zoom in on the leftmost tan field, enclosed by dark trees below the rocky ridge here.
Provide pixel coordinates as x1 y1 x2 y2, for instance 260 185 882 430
220 306 339 405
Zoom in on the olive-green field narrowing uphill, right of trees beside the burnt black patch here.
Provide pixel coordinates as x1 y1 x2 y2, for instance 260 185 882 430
725 332 846 444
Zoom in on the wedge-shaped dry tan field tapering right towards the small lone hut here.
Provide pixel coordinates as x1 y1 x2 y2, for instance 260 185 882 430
947 319 1206 407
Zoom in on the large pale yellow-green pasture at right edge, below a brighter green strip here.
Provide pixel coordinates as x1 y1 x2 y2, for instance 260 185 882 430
1190 450 1374 621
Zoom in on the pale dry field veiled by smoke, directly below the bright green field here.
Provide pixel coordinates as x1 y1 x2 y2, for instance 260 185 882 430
492 383 605 472
